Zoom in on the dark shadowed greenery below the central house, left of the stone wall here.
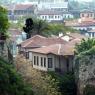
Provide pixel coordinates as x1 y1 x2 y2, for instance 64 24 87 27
49 72 77 95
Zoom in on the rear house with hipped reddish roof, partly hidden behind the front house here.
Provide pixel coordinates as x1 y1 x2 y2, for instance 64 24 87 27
18 35 66 59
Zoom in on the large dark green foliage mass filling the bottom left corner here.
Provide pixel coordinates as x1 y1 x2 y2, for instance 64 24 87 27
0 58 33 95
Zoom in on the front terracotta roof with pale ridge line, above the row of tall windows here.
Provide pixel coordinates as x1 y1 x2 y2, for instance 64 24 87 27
31 44 74 56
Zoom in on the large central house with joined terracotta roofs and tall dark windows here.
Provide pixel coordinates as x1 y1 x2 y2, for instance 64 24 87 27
18 33 85 73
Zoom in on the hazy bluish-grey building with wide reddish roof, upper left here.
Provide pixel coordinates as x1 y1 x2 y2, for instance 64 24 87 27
7 4 37 20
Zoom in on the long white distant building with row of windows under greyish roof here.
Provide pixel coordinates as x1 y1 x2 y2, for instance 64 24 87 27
37 9 74 23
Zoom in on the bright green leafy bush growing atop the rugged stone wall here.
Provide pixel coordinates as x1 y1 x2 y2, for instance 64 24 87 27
76 39 95 54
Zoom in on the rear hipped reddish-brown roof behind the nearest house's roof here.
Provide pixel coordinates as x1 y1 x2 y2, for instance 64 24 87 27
20 35 67 48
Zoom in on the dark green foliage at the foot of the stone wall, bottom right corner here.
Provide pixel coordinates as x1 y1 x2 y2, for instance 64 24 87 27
83 85 95 95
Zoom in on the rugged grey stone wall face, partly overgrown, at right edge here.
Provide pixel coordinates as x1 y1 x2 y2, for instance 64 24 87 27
75 50 95 94
